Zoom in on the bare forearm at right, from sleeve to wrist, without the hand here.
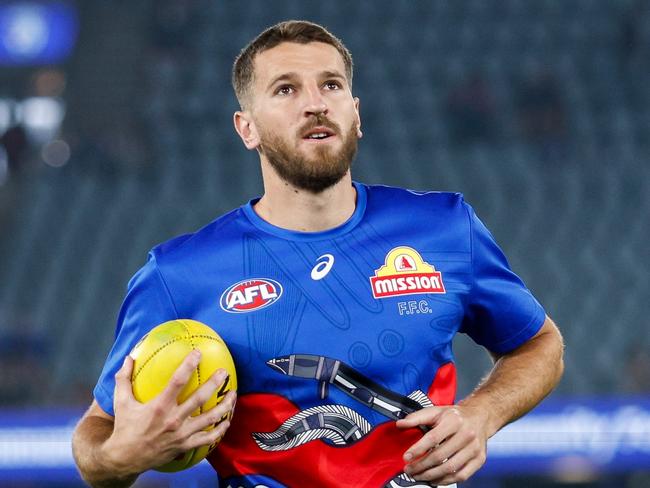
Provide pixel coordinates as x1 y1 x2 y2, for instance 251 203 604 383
459 317 564 436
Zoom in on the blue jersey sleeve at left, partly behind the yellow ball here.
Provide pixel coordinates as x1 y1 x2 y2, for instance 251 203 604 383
93 253 178 416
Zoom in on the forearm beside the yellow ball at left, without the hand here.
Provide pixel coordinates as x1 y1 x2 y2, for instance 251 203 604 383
72 416 138 488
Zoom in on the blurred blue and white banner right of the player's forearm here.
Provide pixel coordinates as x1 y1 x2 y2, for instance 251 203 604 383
482 396 650 479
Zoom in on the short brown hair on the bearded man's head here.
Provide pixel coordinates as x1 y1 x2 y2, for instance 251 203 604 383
232 20 353 107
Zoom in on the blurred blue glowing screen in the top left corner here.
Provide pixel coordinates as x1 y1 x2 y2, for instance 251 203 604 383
0 1 79 66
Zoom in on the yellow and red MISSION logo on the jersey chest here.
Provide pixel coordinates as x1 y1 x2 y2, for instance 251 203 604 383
370 246 446 298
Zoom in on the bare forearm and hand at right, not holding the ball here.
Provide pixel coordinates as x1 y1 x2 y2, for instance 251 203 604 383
397 317 564 485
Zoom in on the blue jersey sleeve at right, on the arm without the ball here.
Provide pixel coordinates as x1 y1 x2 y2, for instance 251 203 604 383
460 205 546 353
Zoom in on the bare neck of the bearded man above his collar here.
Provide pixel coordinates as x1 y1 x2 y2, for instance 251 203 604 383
254 164 356 232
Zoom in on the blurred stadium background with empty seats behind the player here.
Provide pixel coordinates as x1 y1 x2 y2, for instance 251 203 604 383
0 0 650 488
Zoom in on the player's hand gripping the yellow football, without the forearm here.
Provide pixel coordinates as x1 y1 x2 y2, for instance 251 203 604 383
102 350 237 476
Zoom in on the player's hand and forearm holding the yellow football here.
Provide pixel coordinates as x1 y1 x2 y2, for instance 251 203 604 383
72 351 236 488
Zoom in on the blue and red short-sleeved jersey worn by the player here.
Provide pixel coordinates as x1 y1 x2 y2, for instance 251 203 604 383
94 183 545 487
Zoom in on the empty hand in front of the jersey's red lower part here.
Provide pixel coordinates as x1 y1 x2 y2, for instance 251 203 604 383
397 405 488 485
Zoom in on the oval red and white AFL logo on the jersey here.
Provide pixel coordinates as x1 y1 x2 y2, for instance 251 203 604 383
219 278 282 313
